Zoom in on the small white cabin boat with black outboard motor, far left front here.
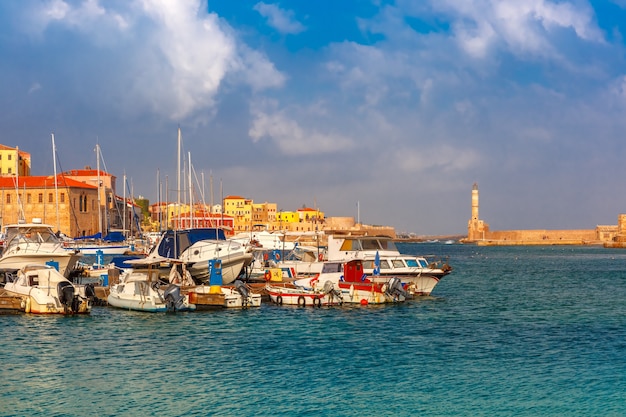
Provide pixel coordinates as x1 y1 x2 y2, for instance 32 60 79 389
4 264 95 314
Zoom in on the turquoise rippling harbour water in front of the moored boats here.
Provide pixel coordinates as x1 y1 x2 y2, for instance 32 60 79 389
0 244 626 416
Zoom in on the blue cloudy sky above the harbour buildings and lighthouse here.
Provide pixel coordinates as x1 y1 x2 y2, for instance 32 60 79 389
0 0 626 235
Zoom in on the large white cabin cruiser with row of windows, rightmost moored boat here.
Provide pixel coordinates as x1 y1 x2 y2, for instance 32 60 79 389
327 235 452 295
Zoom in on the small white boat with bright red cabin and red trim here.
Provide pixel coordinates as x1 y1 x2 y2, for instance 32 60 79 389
294 259 410 305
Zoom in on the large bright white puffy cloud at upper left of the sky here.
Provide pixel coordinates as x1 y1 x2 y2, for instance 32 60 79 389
24 0 285 121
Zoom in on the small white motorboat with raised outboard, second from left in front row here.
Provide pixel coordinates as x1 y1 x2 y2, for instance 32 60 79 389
107 259 196 312
